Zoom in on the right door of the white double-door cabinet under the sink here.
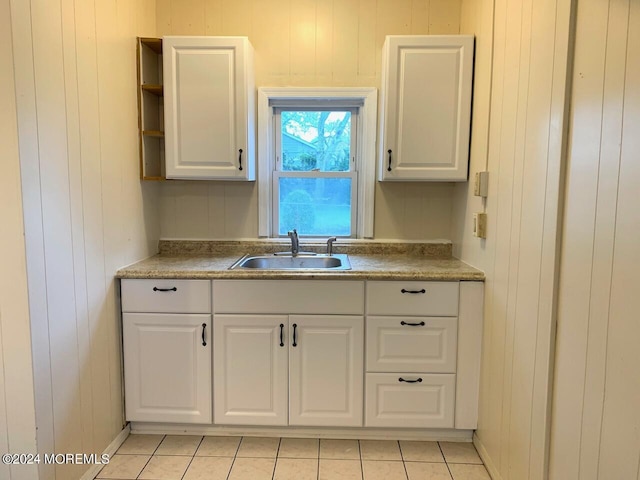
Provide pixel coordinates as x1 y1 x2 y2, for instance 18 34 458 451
289 315 364 427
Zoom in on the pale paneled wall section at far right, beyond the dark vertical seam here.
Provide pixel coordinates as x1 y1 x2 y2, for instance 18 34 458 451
549 0 640 480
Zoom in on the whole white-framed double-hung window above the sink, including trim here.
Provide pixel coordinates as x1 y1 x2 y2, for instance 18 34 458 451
258 87 377 238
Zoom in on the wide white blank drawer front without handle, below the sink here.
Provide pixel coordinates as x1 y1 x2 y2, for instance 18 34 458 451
213 280 364 315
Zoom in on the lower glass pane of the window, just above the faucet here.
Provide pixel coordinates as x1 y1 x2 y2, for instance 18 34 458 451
278 177 351 237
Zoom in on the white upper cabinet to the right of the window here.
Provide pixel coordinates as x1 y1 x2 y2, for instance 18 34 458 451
378 35 474 181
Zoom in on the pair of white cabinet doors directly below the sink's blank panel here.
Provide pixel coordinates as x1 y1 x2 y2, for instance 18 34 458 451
213 314 364 426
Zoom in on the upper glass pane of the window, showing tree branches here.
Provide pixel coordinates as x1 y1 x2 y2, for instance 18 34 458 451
280 110 351 172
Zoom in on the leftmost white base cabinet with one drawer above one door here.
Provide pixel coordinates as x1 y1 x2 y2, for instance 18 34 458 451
121 279 212 424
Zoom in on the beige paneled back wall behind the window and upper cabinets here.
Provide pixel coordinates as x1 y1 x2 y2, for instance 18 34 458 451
157 0 461 240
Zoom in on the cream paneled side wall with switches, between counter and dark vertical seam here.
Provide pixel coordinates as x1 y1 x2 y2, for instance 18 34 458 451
454 0 571 480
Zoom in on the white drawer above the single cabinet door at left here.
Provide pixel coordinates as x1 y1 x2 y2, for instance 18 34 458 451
122 279 211 313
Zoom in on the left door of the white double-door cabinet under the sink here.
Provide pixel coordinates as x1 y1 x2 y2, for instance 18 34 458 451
213 315 288 425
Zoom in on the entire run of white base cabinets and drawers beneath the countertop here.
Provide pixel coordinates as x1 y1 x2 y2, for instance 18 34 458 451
122 280 483 430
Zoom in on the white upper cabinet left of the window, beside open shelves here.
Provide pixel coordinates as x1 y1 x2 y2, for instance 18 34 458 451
163 36 255 180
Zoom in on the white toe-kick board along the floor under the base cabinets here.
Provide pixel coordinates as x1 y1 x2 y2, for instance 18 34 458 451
131 422 473 442
